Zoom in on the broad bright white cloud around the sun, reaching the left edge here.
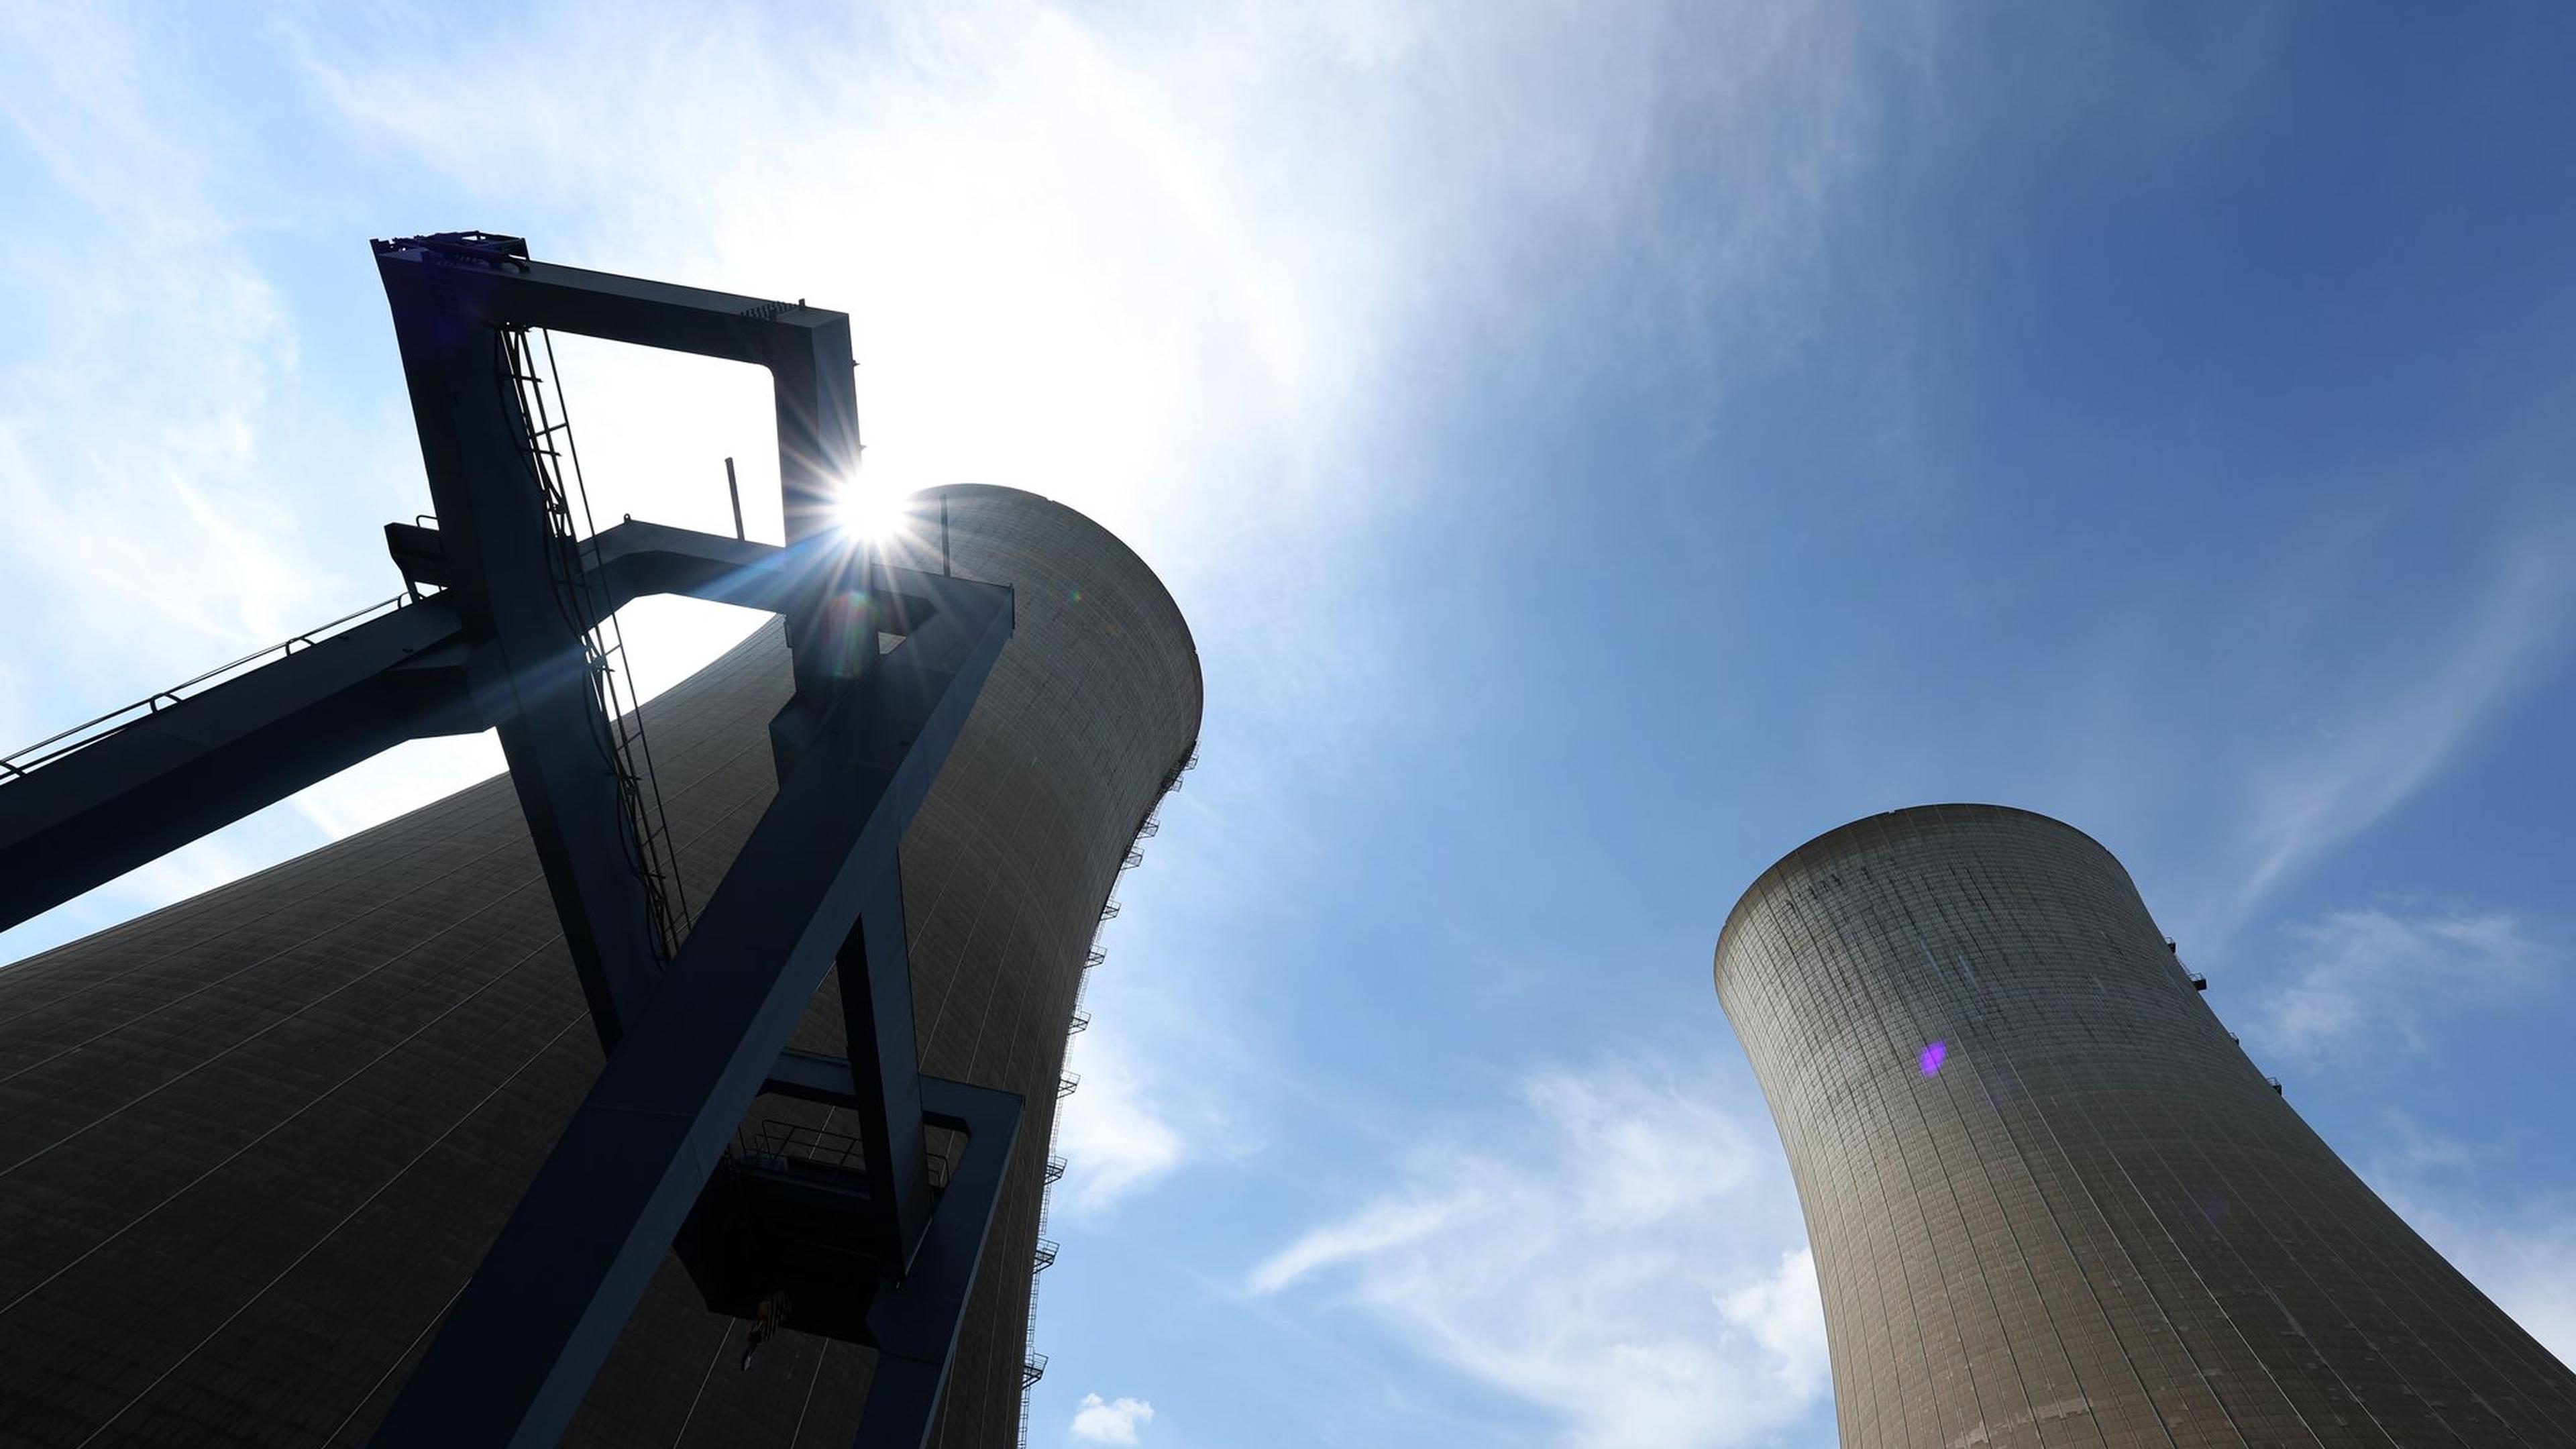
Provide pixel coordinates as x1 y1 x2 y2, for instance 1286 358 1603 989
0 0 1916 938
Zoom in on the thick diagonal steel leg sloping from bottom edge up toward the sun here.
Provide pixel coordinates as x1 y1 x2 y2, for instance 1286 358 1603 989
376 554 1010 1449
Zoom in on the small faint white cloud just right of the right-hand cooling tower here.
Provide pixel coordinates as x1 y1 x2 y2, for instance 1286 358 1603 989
2251 908 2542 1057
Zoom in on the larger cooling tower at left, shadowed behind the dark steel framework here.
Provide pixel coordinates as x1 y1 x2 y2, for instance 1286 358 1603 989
0 487 1200 1449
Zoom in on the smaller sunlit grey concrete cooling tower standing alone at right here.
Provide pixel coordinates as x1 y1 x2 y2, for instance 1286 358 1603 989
1715 804 2576 1449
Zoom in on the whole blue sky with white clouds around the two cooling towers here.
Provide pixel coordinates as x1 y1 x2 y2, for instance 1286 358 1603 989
0 3 2576 1449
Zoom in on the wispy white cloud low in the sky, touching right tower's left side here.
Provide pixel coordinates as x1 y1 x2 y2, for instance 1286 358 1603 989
1247 1046 1824 1449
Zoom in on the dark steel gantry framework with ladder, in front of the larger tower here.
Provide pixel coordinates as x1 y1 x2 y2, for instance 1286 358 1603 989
0 232 1022 1449
